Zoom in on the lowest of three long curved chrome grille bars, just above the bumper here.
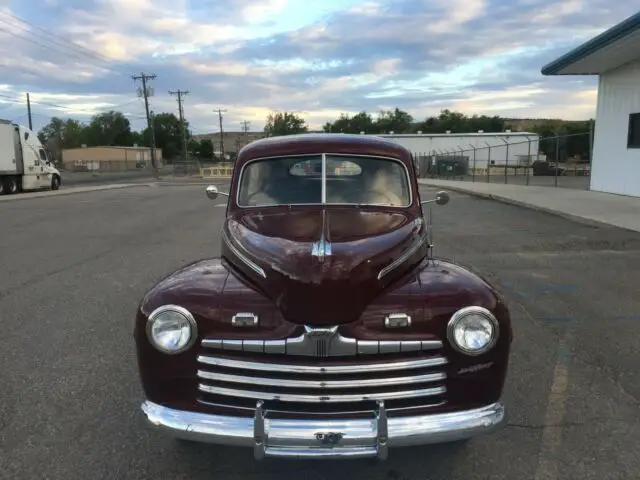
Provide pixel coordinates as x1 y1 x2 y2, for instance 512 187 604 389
198 384 446 403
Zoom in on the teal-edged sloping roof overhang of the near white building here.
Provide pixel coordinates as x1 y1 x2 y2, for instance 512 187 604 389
541 12 640 75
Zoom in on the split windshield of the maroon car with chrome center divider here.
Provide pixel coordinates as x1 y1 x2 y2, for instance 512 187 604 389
238 155 411 207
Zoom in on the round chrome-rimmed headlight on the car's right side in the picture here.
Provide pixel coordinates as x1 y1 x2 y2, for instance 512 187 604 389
447 307 499 355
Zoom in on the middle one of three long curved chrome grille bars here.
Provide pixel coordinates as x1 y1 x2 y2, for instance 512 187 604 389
198 370 446 389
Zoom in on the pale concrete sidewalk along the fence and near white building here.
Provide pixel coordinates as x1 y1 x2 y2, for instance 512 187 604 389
418 179 640 232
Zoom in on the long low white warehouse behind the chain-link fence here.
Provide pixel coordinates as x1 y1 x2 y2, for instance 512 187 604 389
376 131 539 169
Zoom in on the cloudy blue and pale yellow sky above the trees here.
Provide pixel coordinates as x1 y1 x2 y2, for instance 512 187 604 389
0 0 637 133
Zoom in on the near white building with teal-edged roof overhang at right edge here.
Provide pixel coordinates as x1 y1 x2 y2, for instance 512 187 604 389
542 13 640 196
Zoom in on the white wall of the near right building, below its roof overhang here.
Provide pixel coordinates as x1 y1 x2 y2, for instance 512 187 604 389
591 59 640 196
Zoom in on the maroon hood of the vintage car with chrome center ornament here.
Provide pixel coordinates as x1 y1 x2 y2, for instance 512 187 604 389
223 208 427 325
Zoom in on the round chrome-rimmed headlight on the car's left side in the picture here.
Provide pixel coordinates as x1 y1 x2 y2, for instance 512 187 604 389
147 305 197 354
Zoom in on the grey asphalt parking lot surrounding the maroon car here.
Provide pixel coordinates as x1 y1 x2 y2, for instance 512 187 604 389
0 182 640 480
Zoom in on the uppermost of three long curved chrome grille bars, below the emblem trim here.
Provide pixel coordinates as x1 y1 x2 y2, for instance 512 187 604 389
198 355 447 375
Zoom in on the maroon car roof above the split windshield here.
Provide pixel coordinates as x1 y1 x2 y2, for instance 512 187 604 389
235 133 412 168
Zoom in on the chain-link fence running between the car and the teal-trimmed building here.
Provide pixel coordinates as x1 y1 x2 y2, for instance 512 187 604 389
414 132 592 190
